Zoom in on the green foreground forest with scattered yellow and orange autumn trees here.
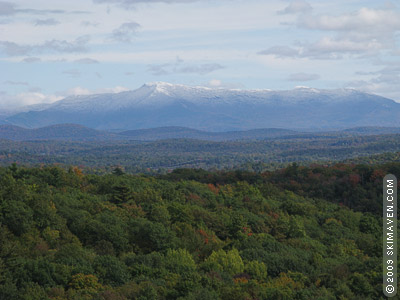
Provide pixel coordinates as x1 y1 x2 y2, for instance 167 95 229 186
0 162 394 300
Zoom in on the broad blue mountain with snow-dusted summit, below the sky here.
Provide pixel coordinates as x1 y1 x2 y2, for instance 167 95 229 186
6 83 400 131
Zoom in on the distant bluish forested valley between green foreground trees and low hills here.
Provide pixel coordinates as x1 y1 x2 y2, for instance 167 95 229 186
0 133 400 174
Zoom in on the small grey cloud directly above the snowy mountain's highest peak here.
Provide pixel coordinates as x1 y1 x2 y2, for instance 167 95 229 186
147 57 224 76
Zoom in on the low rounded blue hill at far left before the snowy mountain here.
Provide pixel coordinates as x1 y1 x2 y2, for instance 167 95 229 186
0 124 122 141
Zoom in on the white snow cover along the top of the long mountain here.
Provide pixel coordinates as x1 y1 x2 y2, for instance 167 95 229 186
14 82 372 112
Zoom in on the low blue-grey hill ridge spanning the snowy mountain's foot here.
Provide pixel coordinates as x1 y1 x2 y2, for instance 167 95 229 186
0 124 400 141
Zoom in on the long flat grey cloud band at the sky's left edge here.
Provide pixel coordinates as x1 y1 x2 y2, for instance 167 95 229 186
0 36 90 56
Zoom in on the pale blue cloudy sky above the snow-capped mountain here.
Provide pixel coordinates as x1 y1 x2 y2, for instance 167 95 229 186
0 0 400 109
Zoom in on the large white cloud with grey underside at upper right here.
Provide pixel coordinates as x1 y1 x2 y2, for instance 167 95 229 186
258 6 400 59
